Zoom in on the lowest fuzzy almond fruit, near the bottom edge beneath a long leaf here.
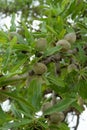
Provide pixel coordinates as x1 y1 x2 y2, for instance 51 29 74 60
49 112 64 124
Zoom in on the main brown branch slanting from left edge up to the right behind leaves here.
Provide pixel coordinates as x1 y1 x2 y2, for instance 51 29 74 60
0 44 87 86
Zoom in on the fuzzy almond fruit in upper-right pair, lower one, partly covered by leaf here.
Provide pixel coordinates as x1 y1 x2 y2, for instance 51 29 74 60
56 39 71 51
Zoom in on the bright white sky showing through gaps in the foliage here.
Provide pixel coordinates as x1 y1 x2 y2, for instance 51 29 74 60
0 4 87 130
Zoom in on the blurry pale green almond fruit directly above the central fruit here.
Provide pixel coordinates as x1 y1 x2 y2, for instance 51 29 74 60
36 38 47 51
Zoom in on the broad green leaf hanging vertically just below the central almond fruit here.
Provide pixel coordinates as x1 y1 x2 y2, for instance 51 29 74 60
27 78 42 111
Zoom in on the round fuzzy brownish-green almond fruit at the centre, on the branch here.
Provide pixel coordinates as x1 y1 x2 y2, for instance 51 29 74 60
33 62 47 75
